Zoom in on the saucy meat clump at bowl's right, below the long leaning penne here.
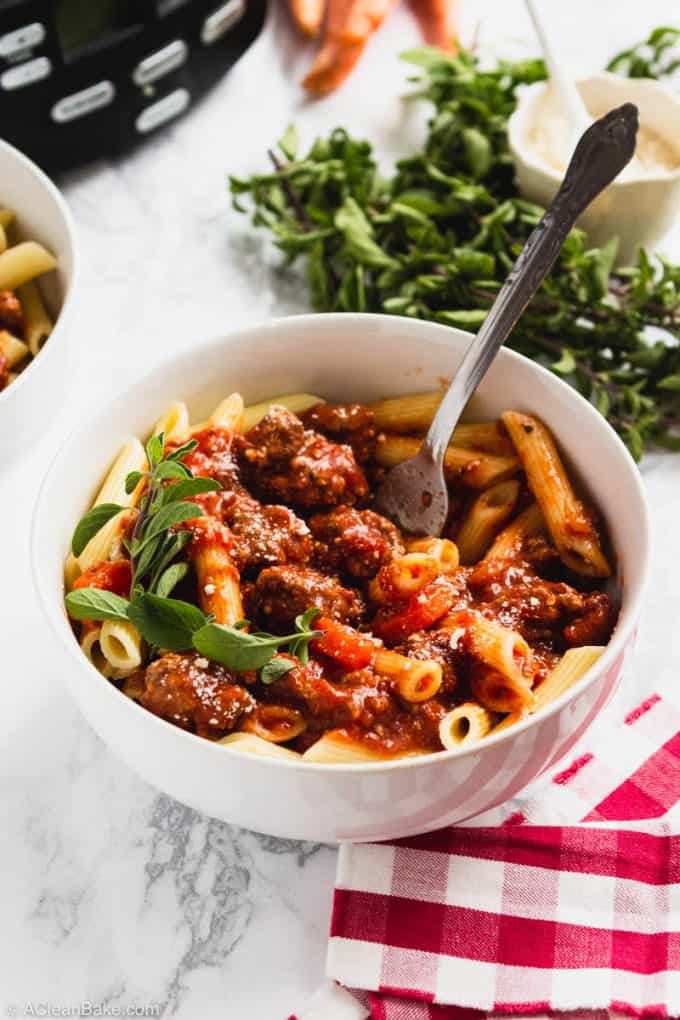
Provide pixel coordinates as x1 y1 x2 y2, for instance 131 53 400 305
468 560 614 650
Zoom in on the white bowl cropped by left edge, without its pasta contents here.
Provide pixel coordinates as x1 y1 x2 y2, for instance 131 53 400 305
0 141 76 468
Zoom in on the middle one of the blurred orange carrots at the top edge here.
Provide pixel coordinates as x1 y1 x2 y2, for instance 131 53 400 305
303 0 397 96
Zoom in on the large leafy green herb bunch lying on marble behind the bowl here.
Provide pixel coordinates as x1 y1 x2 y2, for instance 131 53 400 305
230 30 680 458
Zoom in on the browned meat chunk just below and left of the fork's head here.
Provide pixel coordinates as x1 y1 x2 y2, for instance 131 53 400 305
309 506 405 579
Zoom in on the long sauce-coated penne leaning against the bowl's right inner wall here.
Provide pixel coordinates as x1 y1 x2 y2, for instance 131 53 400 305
503 411 612 577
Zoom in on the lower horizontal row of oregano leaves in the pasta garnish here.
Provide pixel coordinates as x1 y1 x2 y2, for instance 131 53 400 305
65 588 322 683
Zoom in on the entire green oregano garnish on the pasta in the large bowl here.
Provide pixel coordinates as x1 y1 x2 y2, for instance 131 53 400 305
65 434 321 683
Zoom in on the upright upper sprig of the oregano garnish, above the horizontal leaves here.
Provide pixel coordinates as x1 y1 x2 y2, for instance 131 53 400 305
71 432 221 597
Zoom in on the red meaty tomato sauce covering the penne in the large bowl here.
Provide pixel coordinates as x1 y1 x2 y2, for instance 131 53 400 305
65 401 616 761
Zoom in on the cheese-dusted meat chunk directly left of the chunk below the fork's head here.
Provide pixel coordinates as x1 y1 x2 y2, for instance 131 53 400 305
196 491 314 574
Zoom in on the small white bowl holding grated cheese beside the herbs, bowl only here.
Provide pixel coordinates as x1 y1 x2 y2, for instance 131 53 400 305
508 73 680 263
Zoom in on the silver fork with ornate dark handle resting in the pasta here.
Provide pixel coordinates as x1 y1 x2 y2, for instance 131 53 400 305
376 103 638 536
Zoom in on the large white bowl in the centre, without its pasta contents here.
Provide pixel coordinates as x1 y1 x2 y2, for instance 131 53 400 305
32 314 647 842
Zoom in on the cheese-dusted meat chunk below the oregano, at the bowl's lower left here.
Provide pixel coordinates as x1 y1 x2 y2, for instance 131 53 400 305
138 653 255 737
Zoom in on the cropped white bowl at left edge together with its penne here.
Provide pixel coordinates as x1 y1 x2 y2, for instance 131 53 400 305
0 140 76 465
